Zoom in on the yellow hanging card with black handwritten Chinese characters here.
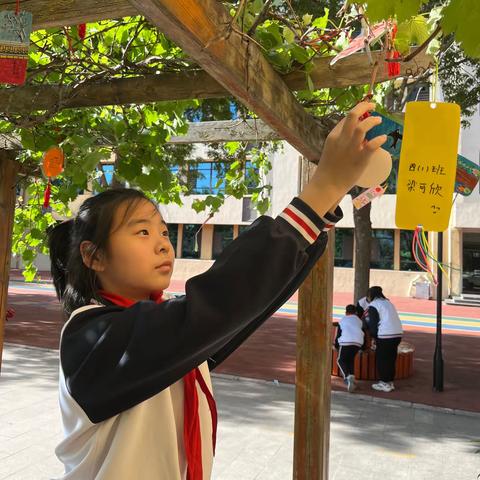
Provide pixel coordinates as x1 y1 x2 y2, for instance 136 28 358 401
395 102 460 232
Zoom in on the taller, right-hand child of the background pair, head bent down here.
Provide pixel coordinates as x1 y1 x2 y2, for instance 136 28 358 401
367 287 403 392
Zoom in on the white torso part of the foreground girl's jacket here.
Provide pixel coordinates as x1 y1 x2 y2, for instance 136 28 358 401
55 305 213 480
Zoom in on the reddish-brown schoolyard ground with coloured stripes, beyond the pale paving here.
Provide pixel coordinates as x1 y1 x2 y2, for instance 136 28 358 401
6 276 480 412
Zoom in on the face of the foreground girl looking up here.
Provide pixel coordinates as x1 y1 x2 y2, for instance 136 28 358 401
89 200 175 300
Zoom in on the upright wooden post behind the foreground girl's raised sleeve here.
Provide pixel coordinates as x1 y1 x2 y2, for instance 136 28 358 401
293 160 335 480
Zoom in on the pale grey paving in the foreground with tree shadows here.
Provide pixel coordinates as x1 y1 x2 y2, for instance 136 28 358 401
0 345 480 480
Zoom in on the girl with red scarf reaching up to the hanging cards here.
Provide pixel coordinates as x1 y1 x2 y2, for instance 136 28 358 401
50 103 386 480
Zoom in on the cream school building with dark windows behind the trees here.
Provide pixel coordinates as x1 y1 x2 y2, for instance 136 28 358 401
12 103 480 302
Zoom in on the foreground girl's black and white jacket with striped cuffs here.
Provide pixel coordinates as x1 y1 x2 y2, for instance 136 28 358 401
56 198 342 480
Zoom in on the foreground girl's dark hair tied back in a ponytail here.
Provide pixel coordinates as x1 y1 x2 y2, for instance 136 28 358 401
48 188 156 316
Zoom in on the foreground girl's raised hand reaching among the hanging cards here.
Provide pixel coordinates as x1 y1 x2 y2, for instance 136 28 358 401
312 102 387 198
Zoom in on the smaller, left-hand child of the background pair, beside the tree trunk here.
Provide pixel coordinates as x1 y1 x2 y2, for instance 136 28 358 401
335 305 365 392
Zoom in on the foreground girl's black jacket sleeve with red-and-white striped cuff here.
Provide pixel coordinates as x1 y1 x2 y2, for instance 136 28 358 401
60 198 342 423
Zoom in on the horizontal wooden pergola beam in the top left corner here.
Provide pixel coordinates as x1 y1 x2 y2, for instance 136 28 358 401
0 0 138 30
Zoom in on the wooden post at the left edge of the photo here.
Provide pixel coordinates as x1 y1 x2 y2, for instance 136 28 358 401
0 150 19 371
